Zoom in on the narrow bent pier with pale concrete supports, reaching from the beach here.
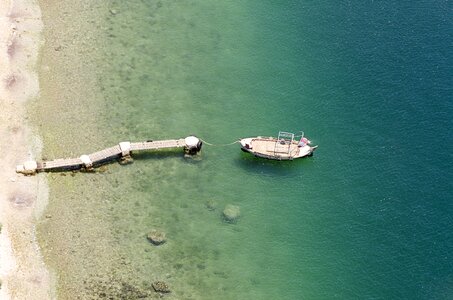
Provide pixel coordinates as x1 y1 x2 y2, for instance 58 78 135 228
16 136 202 175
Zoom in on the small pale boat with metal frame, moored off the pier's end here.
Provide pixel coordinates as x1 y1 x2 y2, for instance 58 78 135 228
240 131 318 160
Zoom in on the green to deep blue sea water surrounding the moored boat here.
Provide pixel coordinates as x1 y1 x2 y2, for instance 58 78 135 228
37 1 453 299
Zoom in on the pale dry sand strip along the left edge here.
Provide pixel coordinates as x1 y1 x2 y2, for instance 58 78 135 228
0 0 54 299
